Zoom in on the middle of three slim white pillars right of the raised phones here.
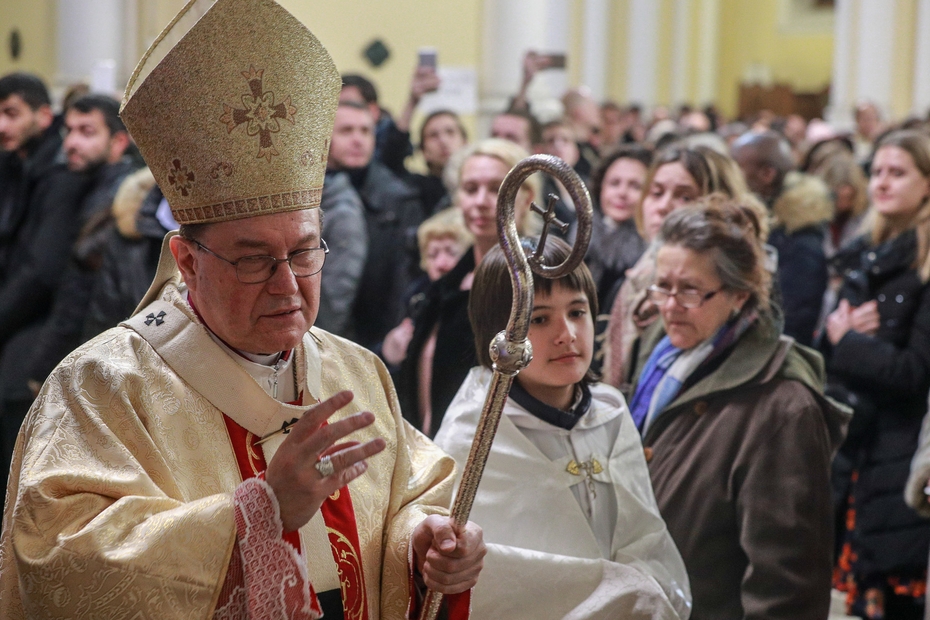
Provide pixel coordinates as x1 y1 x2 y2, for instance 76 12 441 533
626 0 660 110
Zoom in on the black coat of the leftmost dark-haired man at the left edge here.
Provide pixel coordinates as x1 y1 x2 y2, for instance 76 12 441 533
0 129 89 400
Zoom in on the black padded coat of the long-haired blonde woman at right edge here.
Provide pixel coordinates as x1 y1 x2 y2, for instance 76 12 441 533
828 230 930 578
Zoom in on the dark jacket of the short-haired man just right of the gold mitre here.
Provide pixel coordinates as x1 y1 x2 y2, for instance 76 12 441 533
351 161 420 349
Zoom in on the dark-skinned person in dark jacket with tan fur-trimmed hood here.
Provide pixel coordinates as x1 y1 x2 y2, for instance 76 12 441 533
732 131 833 346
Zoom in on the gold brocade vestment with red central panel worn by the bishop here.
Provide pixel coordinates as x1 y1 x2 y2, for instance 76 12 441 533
0 266 454 620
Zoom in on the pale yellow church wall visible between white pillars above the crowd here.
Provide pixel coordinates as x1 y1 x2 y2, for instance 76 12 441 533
0 0 916 123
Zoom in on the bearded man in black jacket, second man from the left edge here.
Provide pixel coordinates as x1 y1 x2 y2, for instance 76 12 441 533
22 95 134 391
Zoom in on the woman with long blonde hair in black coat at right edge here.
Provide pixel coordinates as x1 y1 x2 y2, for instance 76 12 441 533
826 130 930 620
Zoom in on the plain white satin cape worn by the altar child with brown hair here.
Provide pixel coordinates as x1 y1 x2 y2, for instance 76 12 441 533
435 368 691 620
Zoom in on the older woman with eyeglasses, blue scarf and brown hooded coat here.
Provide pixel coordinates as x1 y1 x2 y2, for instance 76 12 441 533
630 194 848 620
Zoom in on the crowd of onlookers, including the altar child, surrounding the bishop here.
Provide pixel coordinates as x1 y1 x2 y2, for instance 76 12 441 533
0 18 930 620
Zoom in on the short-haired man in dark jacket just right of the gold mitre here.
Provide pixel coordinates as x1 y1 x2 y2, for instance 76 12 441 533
328 101 420 349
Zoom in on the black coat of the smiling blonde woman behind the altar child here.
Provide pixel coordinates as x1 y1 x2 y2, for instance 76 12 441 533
397 249 474 435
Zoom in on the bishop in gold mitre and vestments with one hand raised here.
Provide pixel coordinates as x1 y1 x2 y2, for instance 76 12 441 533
0 0 485 620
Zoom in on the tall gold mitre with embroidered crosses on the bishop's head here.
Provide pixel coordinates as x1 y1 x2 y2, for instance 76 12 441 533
120 0 341 224
